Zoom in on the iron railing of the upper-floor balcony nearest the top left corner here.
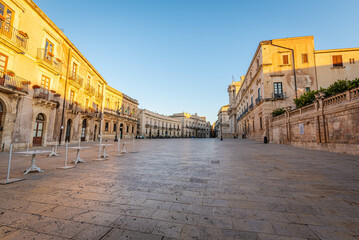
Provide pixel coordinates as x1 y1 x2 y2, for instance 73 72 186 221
0 20 29 49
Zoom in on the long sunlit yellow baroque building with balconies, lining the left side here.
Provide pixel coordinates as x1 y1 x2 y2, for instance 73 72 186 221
0 0 138 149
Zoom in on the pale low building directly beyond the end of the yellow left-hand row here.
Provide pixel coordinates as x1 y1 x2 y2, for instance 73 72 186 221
138 109 182 138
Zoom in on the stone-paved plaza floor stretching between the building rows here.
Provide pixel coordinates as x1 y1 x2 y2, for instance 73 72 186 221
0 139 359 240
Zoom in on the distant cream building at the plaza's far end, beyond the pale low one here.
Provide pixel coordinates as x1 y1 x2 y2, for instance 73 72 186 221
171 113 211 138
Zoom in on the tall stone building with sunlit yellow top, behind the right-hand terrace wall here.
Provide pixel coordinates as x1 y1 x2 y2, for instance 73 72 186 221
228 36 359 141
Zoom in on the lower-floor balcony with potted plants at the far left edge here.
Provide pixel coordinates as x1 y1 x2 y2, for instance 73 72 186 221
0 70 30 94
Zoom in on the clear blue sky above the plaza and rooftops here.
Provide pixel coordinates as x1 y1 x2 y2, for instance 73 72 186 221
34 0 359 123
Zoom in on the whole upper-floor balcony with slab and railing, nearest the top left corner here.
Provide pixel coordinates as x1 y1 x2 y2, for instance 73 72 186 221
0 20 29 54
